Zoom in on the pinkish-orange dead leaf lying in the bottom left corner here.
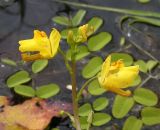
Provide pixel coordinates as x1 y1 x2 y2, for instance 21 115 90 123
0 98 71 130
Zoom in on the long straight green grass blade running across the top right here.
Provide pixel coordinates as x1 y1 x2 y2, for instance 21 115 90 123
53 0 160 18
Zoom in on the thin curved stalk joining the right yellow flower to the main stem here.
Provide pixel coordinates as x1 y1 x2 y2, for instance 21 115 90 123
77 76 97 102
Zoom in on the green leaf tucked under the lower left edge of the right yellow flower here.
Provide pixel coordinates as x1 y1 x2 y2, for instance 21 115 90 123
88 79 107 96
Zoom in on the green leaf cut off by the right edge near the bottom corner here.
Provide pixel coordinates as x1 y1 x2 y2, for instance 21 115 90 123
141 107 160 125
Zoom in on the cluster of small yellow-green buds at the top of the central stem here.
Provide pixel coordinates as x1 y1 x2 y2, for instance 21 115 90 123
67 24 94 44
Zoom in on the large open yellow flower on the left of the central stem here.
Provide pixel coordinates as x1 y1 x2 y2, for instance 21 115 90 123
19 29 61 61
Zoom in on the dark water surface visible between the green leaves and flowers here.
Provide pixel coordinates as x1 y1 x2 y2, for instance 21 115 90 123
0 0 160 130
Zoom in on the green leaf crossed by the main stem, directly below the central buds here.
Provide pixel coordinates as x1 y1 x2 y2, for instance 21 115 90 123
67 45 90 61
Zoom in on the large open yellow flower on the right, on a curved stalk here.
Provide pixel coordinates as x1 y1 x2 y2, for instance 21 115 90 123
98 55 139 96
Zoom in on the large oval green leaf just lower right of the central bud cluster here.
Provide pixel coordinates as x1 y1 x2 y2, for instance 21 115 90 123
87 32 112 51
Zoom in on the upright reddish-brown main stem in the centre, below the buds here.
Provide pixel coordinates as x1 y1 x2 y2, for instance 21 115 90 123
71 53 81 130
